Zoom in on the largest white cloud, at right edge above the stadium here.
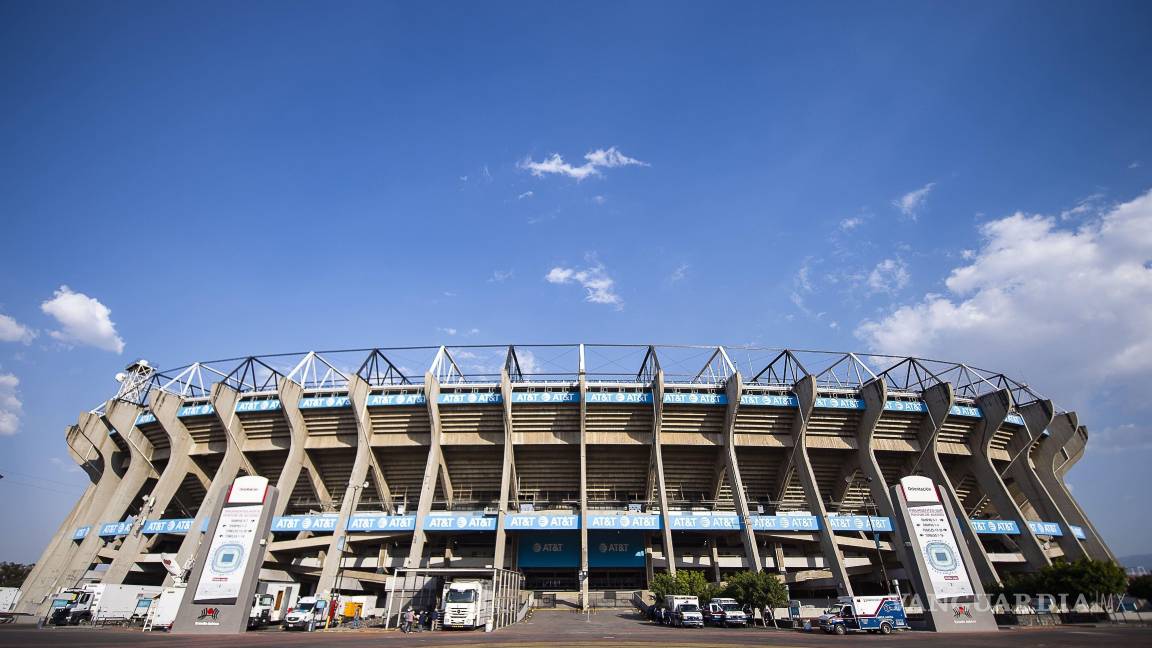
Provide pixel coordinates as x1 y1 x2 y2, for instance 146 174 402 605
856 186 1152 399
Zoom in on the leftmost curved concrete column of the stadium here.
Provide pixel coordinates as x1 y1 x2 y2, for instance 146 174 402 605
15 425 106 615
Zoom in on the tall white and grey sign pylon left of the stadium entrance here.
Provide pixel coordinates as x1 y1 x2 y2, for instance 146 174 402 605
172 476 276 634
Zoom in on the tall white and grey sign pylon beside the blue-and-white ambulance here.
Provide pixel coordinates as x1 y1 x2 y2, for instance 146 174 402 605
892 476 996 632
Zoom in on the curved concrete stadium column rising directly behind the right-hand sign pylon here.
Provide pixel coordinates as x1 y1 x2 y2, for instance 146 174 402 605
907 383 1000 583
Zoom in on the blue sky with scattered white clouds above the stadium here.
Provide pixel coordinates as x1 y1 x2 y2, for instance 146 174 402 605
0 1 1152 560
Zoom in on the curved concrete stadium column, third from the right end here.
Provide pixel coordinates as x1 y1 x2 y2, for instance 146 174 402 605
961 390 1052 570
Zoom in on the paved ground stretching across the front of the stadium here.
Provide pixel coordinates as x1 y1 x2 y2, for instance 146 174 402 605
0 611 1152 648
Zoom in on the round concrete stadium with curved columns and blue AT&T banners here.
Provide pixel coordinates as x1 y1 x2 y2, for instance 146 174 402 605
20 345 1113 612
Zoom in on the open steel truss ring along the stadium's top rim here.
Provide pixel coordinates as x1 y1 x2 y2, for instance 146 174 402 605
93 344 1043 413
